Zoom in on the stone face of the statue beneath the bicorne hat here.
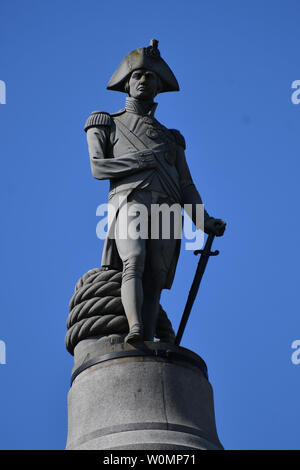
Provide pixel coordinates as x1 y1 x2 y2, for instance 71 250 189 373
129 69 158 101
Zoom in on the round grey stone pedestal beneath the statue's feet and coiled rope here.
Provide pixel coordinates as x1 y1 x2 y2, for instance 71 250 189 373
66 335 222 450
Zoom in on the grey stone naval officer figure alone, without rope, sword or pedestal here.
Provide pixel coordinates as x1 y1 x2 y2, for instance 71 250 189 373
85 39 226 343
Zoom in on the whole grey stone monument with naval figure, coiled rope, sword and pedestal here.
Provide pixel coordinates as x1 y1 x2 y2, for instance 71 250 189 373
66 39 226 451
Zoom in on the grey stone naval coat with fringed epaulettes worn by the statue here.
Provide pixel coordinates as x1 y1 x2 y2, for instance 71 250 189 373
85 98 209 289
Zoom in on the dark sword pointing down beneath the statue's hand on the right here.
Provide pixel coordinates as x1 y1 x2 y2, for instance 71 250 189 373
175 233 219 346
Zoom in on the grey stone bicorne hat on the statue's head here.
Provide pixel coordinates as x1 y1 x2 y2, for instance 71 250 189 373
107 39 179 93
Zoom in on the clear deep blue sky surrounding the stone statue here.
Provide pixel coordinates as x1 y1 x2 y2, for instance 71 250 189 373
0 0 300 449
